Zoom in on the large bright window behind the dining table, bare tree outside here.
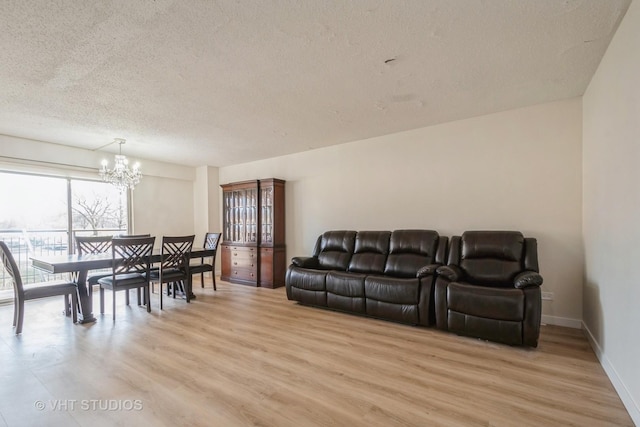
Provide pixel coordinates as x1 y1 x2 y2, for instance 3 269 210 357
0 172 129 300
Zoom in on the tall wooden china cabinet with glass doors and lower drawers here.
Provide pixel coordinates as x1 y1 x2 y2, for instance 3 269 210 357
221 178 286 288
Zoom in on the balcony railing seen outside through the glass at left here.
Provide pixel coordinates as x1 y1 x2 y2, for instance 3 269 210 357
0 228 127 299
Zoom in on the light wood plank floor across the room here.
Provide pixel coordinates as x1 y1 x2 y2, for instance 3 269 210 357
0 281 633 427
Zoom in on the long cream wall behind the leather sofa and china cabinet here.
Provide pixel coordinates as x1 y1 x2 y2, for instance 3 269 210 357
220 98 583 327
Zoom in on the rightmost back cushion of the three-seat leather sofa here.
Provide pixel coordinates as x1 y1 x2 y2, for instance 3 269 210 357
384 230 439 277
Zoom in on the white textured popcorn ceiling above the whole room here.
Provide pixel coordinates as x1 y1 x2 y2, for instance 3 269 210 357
0 0 630 166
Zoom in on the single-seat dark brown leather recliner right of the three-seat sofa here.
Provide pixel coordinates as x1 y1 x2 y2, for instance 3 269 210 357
435 231 542 347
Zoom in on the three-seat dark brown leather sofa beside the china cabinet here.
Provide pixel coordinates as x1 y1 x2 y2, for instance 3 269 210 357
285 230 448 326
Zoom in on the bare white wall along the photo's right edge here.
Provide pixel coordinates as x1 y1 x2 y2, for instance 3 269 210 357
583 2 640 425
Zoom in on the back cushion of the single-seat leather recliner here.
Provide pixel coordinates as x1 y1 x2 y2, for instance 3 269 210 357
460 231 525 287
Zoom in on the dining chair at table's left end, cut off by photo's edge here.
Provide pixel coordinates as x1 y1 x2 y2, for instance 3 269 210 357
0 241 78 335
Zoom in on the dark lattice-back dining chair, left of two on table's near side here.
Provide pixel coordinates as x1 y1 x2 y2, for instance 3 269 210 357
98 237 156 321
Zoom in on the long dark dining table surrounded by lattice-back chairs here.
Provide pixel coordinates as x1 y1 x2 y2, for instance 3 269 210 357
29 248 215 323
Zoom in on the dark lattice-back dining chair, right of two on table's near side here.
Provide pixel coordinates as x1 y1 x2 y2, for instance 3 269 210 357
151 234 195 310
